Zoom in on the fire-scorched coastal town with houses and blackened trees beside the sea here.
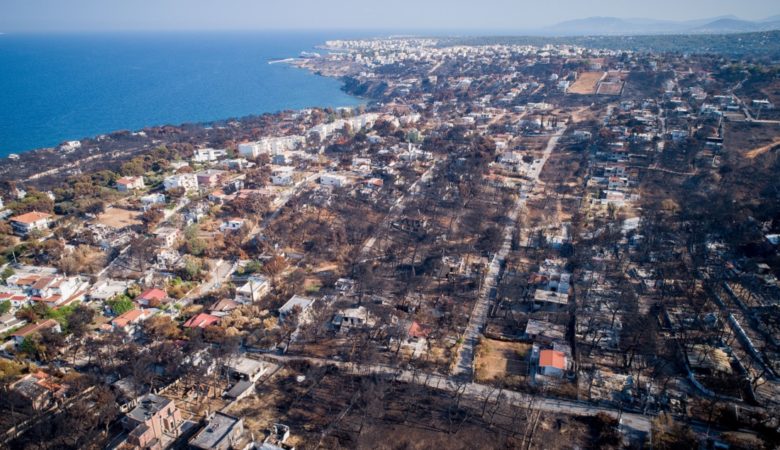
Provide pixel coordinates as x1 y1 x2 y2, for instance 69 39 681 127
0 38 780 450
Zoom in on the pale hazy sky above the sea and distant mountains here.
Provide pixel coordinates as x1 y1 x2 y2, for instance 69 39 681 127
0 0 780 32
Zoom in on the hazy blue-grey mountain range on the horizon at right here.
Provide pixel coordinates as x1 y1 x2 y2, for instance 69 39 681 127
535 15 780 36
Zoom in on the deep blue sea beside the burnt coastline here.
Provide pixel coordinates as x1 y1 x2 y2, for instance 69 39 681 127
0 32 361 156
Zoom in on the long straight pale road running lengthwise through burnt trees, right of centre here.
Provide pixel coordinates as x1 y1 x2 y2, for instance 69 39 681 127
452 128 565 379
